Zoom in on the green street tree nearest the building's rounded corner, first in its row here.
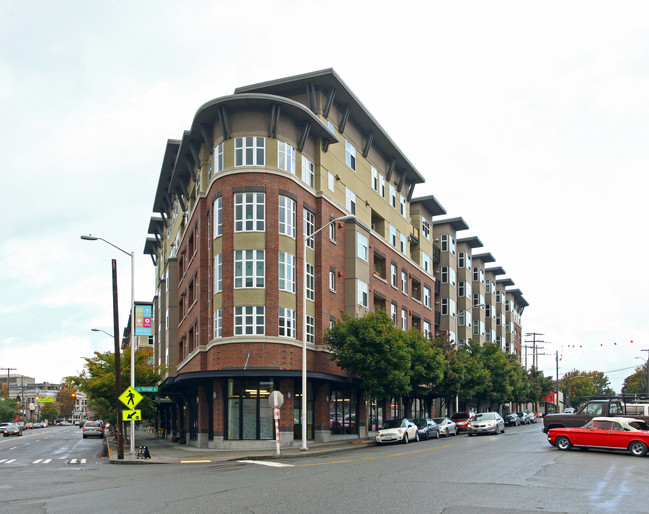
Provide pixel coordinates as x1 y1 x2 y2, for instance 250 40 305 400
324 310 412 437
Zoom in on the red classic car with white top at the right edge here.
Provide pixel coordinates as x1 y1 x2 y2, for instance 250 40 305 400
548 417 649 457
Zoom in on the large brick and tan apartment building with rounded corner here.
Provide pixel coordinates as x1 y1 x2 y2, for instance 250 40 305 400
145 69 523 448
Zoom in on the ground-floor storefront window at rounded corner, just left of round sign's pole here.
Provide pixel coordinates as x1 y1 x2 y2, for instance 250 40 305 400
227 378 274 440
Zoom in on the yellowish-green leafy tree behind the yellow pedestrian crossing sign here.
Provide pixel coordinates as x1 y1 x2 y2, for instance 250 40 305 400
66 347 160 423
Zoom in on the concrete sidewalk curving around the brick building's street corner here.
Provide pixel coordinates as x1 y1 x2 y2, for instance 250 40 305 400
106 430 375 464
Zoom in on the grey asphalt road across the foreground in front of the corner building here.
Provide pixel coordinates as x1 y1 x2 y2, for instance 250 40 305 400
0 424 649 513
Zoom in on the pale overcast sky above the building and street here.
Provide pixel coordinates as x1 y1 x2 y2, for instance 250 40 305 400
0 0 649 390
